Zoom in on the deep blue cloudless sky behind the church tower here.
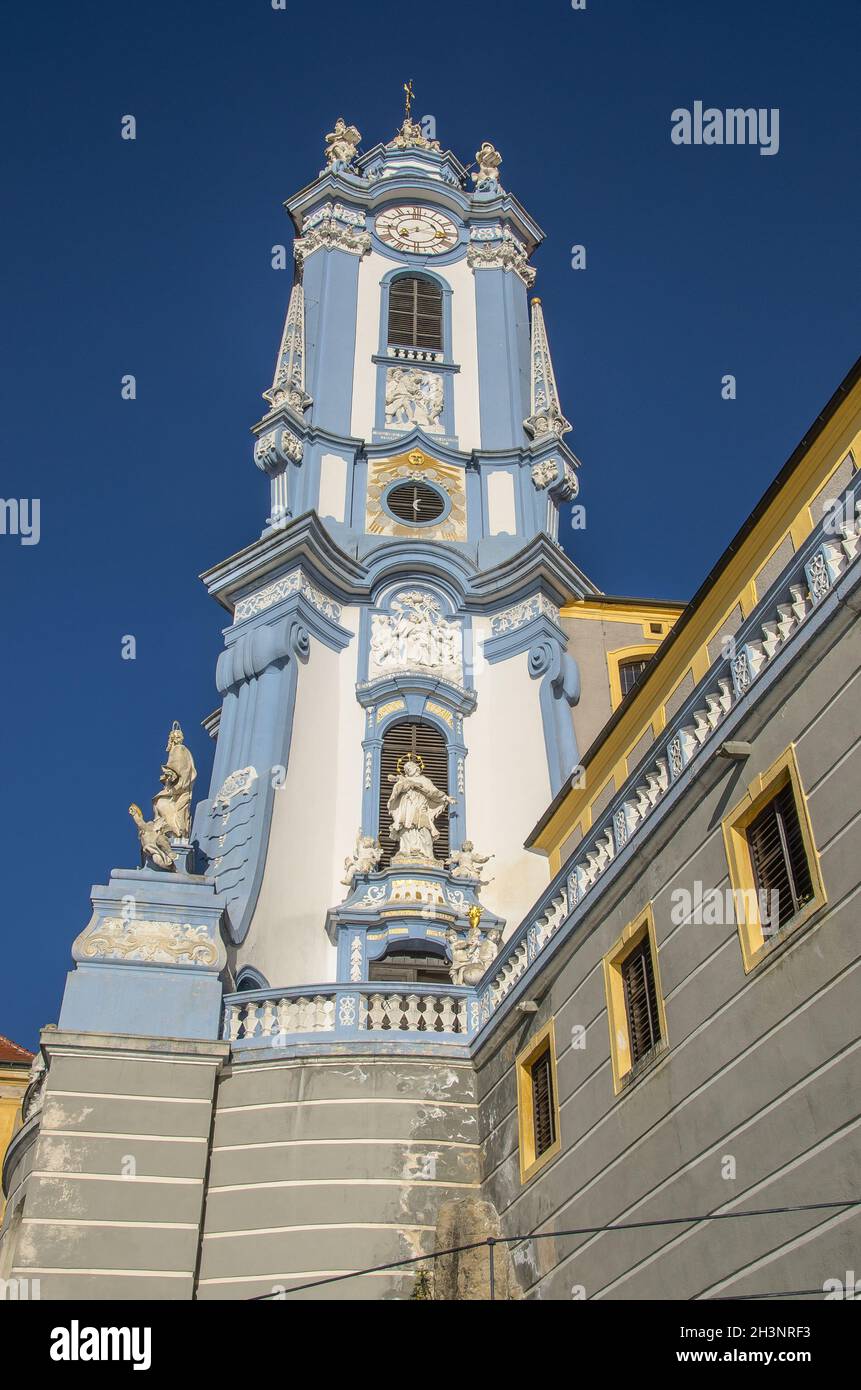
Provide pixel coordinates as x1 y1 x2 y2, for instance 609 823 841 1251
0 0 861 1047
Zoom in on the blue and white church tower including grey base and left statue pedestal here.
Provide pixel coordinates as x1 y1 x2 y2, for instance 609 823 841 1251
3 101 681 1298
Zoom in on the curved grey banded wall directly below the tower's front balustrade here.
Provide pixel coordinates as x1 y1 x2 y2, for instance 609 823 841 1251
198 1056 480 1301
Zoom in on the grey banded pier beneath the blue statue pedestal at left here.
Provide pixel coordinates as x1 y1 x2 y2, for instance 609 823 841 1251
1 1031 228 1300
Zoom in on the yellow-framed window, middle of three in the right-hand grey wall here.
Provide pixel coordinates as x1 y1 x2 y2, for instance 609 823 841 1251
604 904 668 1095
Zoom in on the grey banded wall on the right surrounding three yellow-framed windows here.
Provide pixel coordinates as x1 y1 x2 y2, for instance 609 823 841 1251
477 609 861 1300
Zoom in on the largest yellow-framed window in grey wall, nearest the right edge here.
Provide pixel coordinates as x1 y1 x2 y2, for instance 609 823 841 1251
722 744 826 972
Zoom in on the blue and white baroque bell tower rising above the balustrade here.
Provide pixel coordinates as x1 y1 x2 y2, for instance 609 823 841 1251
183 111 594 986
